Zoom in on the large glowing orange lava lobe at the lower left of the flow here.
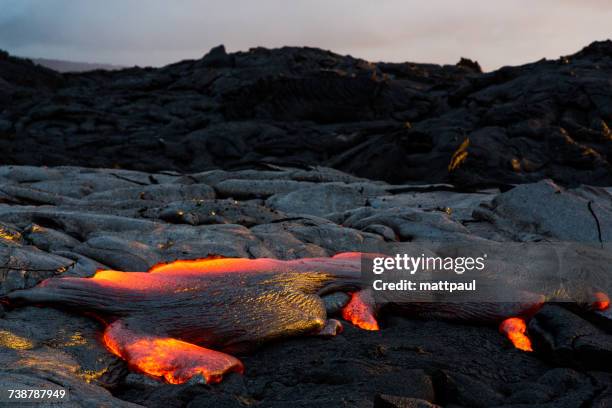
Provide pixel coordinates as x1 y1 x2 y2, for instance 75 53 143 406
103 325 244 384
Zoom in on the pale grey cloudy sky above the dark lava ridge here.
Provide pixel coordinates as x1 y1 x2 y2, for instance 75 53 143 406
0 0 612 70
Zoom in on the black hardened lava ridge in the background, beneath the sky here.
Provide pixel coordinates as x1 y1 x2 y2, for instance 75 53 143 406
0 41 612 187
